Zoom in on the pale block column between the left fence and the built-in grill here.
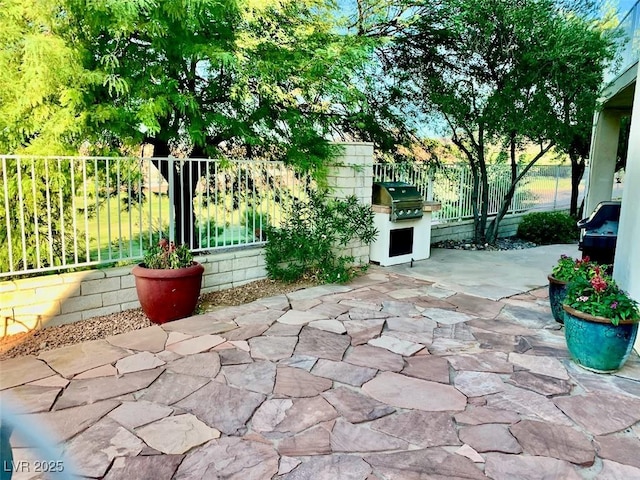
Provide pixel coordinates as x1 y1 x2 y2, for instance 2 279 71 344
327 142 373 264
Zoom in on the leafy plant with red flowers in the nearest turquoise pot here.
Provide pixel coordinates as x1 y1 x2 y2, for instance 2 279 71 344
564 266 640 325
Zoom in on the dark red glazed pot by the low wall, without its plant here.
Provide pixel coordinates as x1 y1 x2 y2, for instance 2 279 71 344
131 262 204 323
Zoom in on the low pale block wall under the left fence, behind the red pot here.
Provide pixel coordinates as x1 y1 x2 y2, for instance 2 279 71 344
0 247 267 337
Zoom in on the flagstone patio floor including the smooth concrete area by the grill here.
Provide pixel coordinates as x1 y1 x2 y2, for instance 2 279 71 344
0 246 640 480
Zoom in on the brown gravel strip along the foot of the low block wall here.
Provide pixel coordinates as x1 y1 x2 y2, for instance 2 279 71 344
0 279 315 360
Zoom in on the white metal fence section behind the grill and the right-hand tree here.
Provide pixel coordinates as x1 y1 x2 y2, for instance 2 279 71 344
373 163 584 223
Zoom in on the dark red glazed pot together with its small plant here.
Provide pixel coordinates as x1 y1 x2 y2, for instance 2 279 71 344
131 238 204 323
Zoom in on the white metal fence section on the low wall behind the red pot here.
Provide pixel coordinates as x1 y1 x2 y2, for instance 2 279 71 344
0 155 315 277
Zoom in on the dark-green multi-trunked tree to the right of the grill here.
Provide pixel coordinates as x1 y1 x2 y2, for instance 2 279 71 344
395 0 612 243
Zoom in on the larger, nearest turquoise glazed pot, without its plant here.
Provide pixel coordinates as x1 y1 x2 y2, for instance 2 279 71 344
563 305 638 373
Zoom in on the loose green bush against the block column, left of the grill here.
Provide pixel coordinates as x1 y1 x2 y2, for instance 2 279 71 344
265 193 377 283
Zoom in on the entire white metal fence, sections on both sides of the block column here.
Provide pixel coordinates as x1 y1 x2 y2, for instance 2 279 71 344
0 155 584 278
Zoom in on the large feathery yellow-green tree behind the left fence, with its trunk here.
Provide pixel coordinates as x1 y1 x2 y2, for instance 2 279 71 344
0 0 404 255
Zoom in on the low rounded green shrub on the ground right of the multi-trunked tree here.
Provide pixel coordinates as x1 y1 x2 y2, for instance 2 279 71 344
518 212 580 245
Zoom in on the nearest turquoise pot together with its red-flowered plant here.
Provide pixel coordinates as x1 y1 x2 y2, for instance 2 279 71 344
563 266 640 373
